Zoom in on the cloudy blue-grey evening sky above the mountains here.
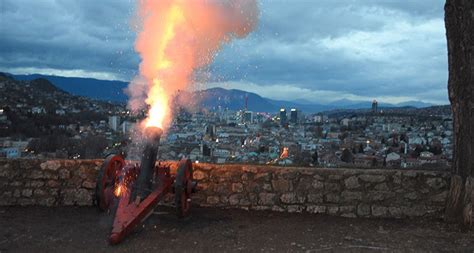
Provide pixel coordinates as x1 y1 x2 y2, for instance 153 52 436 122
0 0 448 104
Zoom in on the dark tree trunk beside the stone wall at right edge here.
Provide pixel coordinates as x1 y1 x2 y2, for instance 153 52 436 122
444 0 474 229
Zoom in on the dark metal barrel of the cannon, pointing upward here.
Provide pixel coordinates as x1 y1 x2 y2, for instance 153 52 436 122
135 127 163 200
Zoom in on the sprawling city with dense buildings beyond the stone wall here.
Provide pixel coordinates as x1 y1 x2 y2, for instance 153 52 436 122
0 73 453 170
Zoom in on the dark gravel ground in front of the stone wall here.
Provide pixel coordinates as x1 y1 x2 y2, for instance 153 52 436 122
0 207 474 253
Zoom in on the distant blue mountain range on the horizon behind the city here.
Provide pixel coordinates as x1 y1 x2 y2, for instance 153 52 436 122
8 74 432 113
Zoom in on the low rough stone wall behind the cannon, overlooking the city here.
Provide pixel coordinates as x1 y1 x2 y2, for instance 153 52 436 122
0 160 449 218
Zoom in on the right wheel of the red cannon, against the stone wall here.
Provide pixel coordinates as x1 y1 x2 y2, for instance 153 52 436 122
174 158 193 218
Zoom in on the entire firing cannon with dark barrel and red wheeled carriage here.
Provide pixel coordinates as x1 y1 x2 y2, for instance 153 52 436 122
95 127 197 244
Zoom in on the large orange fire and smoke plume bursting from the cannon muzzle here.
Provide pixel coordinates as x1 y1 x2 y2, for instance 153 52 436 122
128 0 258 129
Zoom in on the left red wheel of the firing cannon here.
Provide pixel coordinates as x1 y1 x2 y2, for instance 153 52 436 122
95 154 125 212
